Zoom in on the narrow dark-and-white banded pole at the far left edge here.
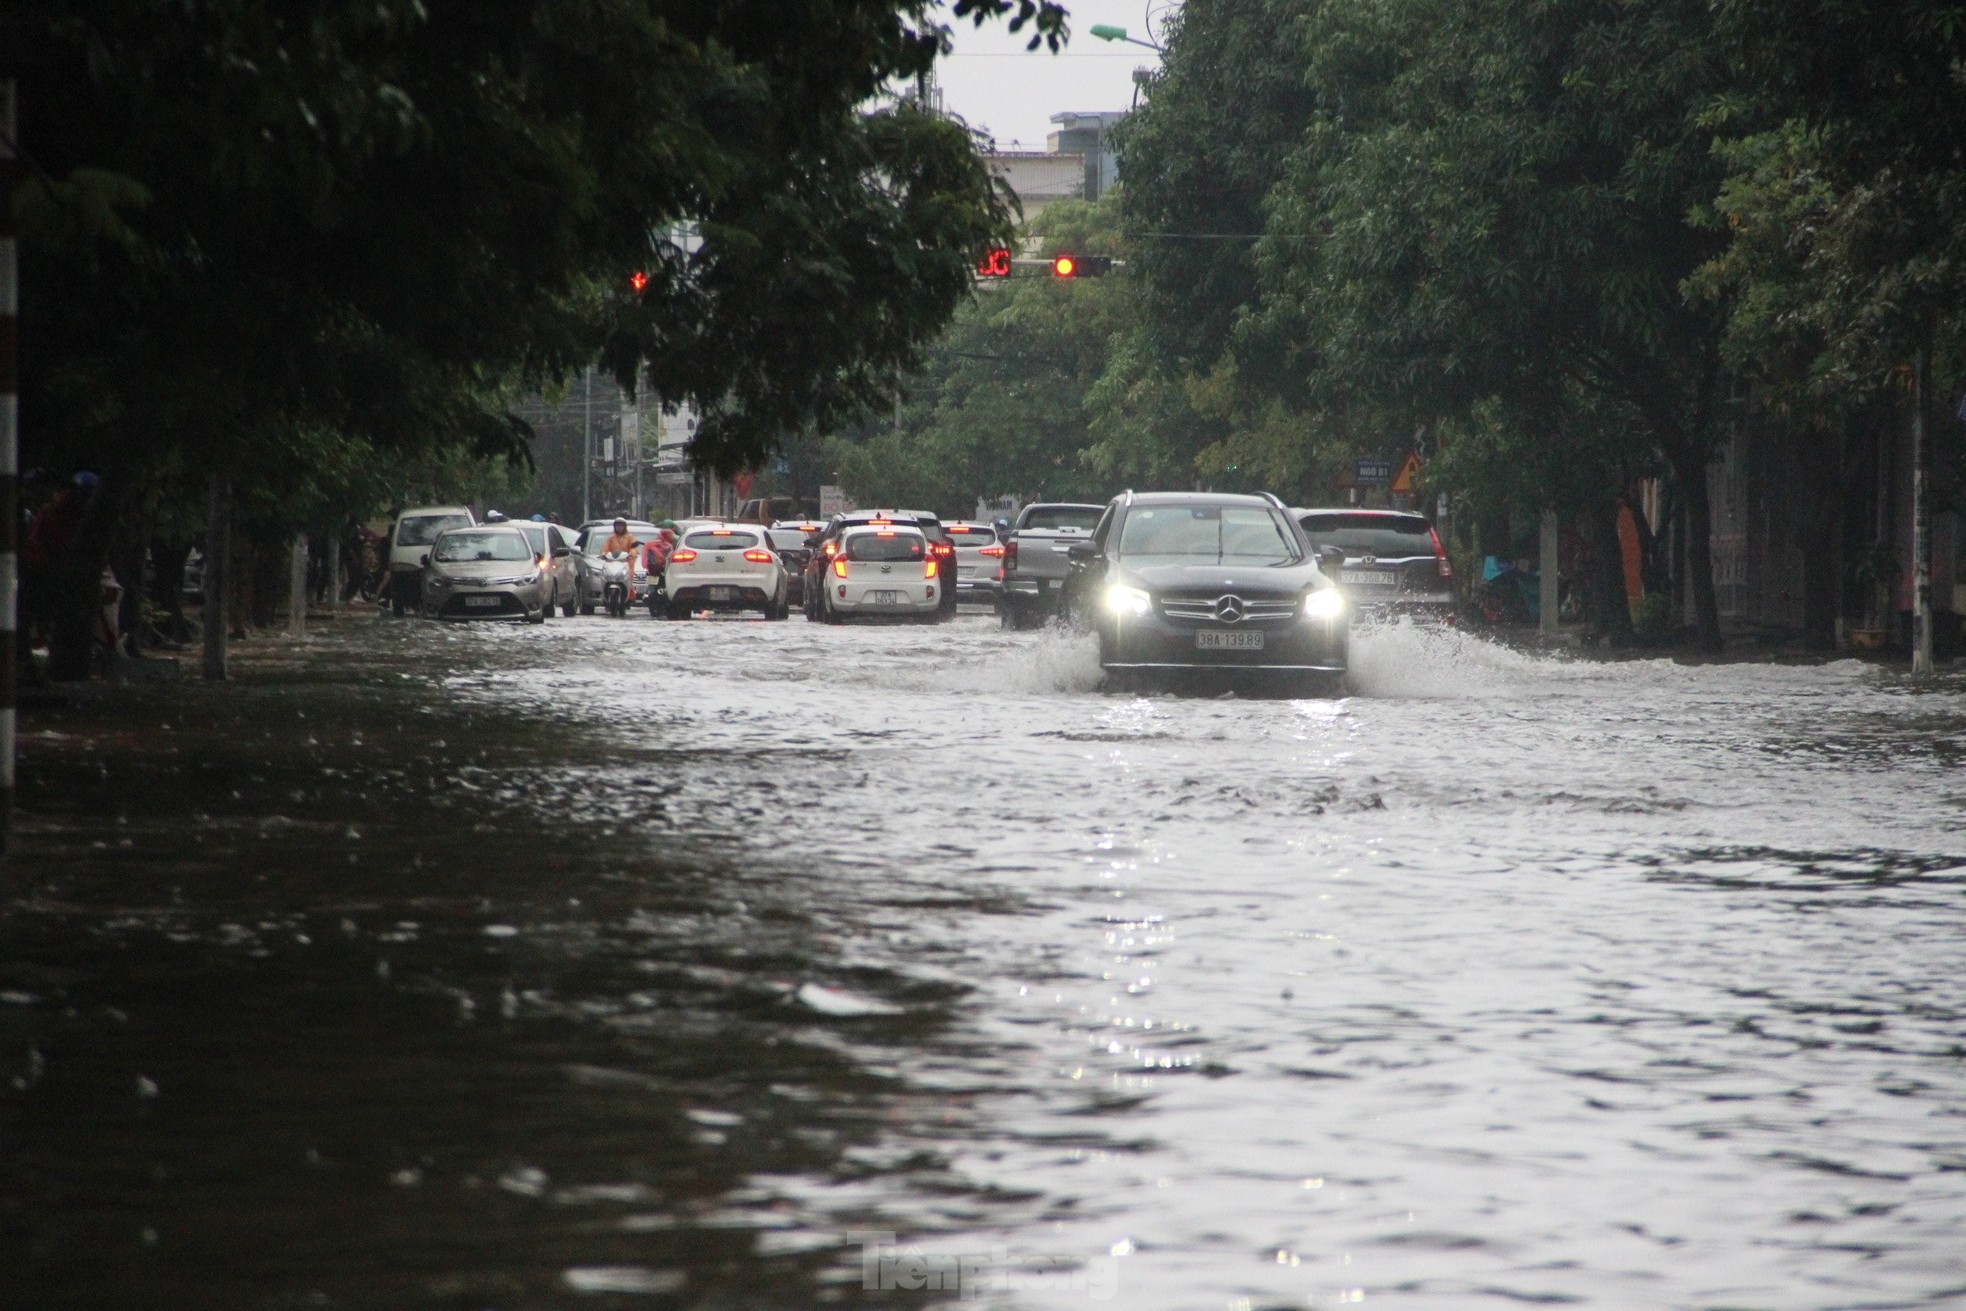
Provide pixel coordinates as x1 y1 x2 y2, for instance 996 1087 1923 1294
0 77 20 857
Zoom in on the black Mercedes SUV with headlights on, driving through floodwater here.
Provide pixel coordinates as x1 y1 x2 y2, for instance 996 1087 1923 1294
1068 491 1351 692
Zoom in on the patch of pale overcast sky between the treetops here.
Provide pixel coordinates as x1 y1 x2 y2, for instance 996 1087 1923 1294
936 0 1178 149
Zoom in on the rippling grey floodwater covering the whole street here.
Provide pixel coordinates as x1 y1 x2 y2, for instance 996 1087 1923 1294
0 615 1966 1311
